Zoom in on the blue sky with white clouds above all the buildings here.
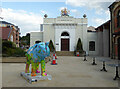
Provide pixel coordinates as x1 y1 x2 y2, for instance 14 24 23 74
0 0 114 36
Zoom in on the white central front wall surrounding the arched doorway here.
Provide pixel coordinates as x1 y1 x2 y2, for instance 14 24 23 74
43 16 88 51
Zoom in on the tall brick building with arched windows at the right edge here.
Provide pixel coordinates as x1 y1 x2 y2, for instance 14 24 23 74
109 1 120 60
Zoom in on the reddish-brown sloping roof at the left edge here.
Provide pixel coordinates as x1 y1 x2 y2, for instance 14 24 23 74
0 27 12 40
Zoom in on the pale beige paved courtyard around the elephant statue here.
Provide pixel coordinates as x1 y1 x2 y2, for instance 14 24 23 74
2 56 118 87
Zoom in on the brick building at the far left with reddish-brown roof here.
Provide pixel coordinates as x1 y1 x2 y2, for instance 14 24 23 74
0 21 20 47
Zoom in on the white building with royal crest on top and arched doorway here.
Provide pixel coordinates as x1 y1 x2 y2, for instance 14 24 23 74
30 9 109 55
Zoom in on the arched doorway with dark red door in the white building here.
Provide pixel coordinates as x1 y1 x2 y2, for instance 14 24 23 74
61 32 70 51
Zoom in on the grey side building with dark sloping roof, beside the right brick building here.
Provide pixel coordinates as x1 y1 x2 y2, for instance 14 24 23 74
96 20 110 57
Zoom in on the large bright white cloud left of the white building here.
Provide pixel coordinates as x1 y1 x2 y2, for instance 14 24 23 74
1 8 43 35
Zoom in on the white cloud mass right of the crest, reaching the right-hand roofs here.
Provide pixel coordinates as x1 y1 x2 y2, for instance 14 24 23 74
66 0 112 26
